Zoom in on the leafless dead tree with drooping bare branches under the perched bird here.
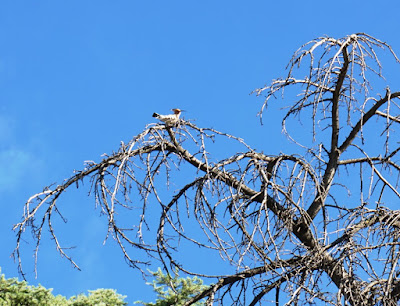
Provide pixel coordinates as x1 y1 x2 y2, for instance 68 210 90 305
14 33 400 305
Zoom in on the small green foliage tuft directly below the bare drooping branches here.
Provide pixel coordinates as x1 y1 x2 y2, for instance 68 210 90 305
135 268 208 306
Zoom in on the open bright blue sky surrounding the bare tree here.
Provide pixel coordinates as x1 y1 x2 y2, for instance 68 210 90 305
0 0 400 302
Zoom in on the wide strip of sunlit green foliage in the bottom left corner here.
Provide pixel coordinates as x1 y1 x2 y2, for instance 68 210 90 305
0 268 127 306
